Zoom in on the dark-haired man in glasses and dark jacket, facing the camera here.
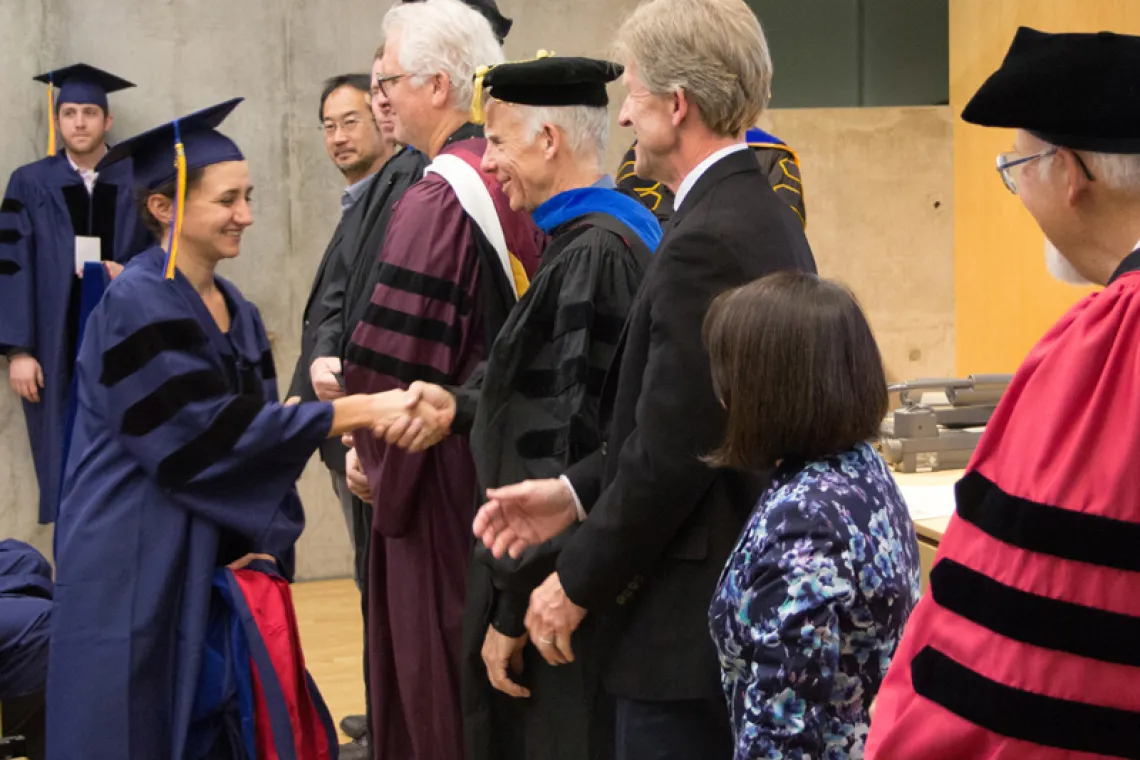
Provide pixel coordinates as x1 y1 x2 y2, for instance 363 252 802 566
288 74 426 760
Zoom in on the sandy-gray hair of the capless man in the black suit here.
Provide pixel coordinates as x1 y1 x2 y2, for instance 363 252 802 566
616 0 772 137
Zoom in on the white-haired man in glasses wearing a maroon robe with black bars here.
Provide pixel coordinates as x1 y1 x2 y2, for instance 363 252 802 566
344 0 544 760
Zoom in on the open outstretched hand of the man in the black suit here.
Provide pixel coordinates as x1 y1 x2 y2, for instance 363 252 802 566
473 480 578 559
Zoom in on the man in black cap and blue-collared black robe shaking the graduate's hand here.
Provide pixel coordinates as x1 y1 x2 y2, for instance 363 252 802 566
389 57 661 760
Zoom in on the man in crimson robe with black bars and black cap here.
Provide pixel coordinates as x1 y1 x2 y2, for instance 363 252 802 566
866 27 1140 760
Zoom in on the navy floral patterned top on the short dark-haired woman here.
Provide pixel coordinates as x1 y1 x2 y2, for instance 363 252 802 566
709 443 919 760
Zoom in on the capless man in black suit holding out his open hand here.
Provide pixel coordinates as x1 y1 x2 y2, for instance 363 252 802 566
475 0 815 760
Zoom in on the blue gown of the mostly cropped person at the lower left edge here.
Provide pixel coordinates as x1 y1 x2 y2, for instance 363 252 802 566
0 539 51 701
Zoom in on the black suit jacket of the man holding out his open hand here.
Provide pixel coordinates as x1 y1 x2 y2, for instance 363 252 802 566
557 150 815 700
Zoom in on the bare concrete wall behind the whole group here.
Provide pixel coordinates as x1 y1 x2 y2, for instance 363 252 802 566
0 0 953 578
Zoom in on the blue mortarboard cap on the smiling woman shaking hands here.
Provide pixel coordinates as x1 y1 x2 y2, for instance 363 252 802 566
96 98 245 190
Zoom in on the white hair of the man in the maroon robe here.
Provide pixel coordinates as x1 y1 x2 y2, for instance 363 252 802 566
383 0 504 111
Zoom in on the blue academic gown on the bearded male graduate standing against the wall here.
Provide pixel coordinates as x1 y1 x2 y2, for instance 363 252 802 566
0 152 153 523
